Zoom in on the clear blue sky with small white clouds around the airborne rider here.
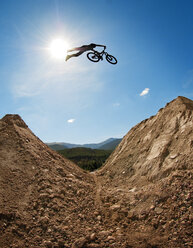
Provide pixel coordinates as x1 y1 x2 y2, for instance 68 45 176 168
0 0 193 144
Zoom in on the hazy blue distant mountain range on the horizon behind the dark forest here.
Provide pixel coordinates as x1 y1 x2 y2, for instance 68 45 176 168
46 138 121 151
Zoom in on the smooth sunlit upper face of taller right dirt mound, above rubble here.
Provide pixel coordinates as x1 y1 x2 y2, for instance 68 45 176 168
101 97 193 185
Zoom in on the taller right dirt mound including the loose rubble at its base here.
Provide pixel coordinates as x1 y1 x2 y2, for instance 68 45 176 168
97 97 193 247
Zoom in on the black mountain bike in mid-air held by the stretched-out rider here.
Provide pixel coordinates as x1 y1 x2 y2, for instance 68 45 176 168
87 49 117 65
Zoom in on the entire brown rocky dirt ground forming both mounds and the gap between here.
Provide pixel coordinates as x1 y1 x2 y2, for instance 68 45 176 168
0 97 193 248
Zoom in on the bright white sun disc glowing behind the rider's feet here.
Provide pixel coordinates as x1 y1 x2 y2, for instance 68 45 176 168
49 39 69 59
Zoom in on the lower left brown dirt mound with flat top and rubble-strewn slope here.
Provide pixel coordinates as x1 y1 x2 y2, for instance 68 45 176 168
0 115 107 248
